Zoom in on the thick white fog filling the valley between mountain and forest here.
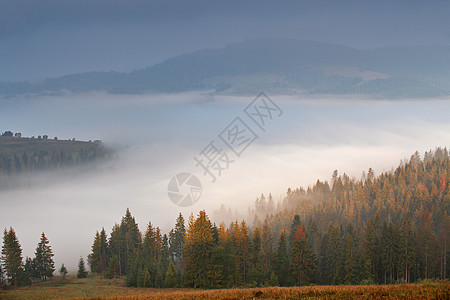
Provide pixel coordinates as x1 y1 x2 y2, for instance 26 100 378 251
0 92 450 268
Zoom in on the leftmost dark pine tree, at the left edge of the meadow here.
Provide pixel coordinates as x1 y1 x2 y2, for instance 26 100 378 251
2 227 24 287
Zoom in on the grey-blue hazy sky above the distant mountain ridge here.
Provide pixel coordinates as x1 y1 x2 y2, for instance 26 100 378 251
0 0 450 81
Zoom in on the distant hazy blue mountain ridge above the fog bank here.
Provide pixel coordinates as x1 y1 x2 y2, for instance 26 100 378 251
0 39 450 98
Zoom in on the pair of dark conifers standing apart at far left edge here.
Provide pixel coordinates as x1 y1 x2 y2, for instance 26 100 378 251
0 228 55 287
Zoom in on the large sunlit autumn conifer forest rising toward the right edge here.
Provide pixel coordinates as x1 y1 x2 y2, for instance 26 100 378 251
81 148 450 288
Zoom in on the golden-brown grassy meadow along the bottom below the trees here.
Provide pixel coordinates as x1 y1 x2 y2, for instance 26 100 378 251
0 276 450 300
